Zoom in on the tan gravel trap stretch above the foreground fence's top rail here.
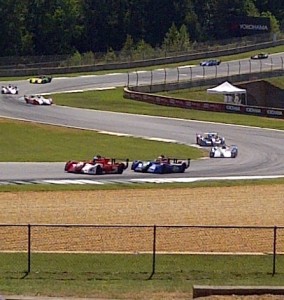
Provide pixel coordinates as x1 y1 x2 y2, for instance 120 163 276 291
0 185 284 226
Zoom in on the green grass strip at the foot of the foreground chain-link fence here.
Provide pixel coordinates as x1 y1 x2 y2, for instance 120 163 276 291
0 253 284 299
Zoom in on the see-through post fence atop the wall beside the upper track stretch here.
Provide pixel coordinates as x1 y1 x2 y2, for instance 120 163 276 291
126 56 284 92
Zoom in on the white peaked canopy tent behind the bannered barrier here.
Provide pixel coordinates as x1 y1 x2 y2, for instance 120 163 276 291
207 81 247 104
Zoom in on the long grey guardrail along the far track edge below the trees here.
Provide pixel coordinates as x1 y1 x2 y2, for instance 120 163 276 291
0 35 284 77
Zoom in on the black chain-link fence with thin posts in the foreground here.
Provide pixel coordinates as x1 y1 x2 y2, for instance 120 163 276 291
0 224 284 278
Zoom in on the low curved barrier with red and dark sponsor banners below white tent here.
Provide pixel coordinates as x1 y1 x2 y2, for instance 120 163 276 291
124 88 284 119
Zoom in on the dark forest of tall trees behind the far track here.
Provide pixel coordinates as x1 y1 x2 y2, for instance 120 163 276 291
0 0 284 57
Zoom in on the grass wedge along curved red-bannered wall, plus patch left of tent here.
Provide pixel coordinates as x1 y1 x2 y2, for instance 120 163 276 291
52 88 284 130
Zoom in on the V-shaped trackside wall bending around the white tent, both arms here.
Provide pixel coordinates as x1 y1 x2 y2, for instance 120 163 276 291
124 70 284 119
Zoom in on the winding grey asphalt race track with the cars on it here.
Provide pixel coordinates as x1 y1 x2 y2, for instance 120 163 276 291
0 55 284 182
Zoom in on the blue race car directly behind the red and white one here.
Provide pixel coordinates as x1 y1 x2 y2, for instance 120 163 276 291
131 157 190 174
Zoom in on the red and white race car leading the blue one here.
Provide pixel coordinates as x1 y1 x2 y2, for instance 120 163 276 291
64 157 129 175
